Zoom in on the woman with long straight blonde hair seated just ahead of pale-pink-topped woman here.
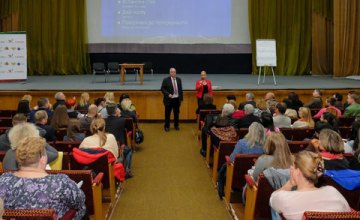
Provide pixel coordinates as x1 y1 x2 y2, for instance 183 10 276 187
252 132 292 180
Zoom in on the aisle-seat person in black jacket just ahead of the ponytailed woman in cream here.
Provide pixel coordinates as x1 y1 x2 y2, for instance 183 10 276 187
105 103 126 145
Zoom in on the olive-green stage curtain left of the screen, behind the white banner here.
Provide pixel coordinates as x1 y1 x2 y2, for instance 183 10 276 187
0 0 90 75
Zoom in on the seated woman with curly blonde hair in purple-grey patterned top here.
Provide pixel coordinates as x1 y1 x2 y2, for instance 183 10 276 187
0 137 86 219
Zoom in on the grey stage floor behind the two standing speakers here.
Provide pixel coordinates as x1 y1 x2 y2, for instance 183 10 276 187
0 74 360 91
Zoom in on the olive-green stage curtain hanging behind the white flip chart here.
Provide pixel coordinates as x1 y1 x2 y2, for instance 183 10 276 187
249 0 312 75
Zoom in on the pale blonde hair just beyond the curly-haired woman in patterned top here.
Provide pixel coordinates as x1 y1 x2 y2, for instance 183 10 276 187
9 122 40 150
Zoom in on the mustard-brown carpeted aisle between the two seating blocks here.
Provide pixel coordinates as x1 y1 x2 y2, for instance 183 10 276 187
112 123 231 220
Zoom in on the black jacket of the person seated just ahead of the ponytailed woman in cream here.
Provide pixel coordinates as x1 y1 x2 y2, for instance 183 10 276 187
105 115 126 144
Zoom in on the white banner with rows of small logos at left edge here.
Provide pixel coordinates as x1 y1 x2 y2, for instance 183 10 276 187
0 32 27 81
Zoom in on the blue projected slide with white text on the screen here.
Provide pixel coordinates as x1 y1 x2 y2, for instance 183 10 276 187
101 0 232 37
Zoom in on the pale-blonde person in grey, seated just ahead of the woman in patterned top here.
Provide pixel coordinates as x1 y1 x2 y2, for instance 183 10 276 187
3 123 58 170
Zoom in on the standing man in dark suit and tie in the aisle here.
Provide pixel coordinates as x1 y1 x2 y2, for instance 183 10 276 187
161 67 183 131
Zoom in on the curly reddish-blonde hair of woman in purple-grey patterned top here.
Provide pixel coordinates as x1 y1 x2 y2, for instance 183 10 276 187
16 137 46 167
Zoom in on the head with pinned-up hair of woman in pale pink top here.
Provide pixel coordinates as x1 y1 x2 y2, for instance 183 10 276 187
290 150 324 186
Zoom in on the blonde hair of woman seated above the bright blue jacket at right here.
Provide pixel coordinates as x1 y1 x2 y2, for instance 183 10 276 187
319 129 344 154
